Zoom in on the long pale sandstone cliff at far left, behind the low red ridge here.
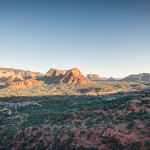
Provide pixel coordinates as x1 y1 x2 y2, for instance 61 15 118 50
0 68 43 83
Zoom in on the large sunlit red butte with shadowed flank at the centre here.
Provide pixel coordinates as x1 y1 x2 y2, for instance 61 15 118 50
46 68 88 85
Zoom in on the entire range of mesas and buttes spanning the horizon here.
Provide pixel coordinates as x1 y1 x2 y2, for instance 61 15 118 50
0 68 150 88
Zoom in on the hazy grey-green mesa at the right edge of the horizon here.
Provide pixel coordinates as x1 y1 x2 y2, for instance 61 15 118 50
122 73 150 82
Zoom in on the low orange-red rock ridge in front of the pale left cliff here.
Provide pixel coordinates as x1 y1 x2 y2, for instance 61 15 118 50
7 79 44 88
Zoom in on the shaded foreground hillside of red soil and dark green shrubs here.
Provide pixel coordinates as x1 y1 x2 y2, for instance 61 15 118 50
0 93 150 150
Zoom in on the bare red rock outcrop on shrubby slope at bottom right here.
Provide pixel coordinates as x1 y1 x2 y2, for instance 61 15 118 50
103 128 135 147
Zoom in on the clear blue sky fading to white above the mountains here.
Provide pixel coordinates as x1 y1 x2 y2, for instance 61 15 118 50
0 0 150 77
